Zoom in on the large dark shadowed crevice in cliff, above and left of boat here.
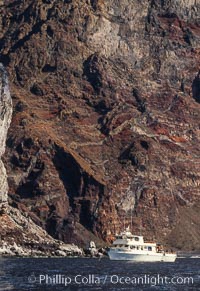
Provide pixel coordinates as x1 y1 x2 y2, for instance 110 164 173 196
53 145 104 230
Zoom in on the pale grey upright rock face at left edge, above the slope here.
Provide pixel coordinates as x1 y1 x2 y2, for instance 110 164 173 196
0 64 12 206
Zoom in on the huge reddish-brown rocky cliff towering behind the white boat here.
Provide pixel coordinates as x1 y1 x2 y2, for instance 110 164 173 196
0 0 200 249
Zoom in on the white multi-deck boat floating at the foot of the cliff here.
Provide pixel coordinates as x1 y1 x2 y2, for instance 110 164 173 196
108 228 177 262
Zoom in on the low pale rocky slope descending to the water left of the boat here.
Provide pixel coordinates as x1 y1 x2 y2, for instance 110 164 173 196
0 206 105 257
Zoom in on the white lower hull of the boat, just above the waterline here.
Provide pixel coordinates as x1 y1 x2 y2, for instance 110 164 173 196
108 250 176 262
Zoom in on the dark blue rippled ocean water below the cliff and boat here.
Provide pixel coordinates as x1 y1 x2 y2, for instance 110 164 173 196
0 258 200 291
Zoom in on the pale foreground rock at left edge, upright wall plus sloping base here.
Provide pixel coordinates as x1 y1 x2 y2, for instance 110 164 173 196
0 63 82 256
